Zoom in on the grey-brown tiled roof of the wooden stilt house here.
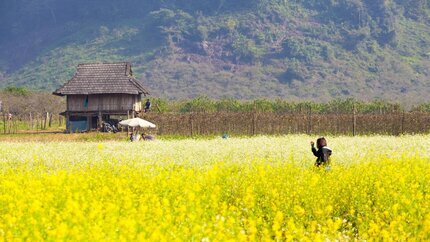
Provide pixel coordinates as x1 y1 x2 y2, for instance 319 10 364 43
54 62 149 96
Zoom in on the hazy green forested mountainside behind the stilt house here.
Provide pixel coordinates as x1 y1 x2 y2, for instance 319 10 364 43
0 0 430 103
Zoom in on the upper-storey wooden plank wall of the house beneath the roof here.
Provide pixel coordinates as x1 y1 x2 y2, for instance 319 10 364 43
67 94 142 112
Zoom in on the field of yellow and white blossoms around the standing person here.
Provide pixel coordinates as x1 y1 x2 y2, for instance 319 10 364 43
0 135 430 241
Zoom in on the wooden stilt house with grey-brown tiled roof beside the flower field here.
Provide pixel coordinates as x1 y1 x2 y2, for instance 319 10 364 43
53 62 149 132
